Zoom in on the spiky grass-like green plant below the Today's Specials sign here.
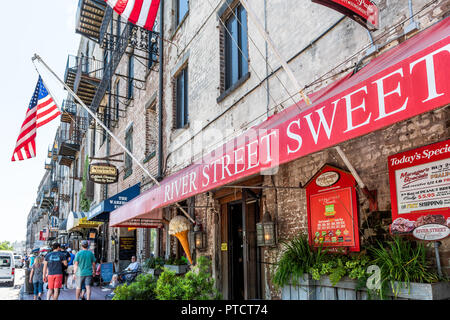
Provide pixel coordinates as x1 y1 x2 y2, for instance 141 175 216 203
370 237 439 295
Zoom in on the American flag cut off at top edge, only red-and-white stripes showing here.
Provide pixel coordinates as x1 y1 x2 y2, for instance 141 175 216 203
105 0 160 31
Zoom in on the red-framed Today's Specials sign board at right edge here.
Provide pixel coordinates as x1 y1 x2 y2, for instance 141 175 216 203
388 140 450 234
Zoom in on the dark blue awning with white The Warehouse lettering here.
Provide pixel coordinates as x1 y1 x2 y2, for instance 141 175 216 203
87 183 141 222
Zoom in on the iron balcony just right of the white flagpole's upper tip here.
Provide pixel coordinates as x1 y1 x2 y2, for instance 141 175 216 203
64 55 103 106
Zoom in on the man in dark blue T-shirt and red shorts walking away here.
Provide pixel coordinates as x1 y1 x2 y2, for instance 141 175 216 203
43 243 67 300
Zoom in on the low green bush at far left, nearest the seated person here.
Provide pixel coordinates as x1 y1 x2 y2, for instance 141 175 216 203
113 274 156 300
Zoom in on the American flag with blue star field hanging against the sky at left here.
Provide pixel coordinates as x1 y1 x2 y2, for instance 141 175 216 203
11 76 61 161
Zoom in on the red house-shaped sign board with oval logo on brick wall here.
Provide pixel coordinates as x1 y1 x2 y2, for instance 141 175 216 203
305 165 359 251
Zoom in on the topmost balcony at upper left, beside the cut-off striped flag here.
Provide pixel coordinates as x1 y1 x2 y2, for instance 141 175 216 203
75 0 107 42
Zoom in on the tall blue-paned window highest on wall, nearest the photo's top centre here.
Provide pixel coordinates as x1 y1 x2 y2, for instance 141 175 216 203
224 5 248 90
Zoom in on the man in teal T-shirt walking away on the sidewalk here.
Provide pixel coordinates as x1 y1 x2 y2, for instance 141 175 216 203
73 240 95 300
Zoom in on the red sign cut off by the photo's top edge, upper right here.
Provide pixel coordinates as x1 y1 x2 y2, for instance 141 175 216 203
312 0 379 29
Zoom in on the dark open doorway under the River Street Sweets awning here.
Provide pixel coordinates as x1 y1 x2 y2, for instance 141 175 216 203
227 191 261 300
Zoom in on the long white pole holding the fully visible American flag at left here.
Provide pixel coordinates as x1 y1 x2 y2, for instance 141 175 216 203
31 53 196 225
